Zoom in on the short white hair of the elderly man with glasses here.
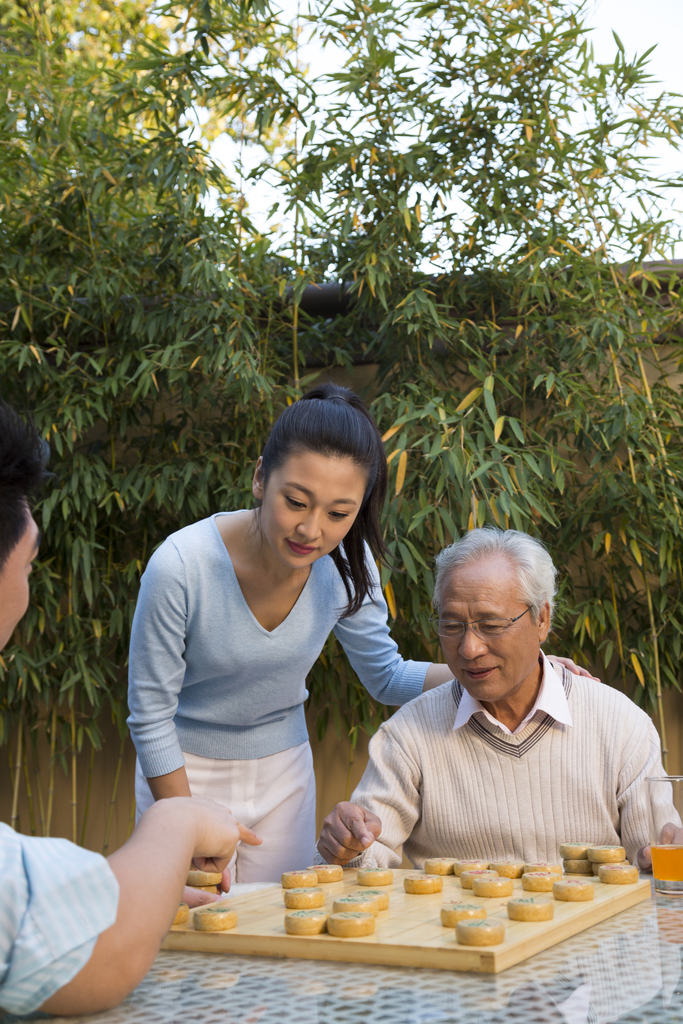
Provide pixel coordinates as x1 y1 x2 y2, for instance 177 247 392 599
433 526 557 621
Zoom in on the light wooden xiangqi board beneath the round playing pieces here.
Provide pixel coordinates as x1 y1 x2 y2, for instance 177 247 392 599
162 868 650 974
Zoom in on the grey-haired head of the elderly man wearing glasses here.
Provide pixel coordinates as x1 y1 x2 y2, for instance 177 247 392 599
434 528 557 703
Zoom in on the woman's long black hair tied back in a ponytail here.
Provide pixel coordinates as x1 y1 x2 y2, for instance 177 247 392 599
261 384 387 616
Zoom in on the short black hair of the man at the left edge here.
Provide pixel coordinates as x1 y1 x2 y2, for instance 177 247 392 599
0 400 45 571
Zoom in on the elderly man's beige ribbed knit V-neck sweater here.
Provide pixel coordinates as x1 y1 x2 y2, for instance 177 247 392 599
351 670 664 867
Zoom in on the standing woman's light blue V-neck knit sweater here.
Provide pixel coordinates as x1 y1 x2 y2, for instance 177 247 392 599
128 513 429 778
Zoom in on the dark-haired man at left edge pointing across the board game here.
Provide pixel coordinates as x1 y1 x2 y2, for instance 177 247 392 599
0 401 260 1015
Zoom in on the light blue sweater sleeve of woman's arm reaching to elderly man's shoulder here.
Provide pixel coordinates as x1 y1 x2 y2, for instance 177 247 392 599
334 546 430 706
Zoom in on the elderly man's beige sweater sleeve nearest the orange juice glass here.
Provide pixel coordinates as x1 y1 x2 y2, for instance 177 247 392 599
616 714 678 864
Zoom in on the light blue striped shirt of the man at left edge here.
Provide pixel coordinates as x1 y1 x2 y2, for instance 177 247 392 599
0 822 119 1014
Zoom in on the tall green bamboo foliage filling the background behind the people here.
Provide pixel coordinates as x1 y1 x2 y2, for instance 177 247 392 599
0 0 683 839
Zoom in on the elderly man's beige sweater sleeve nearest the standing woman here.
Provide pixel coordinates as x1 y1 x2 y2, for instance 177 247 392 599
351 723 422 867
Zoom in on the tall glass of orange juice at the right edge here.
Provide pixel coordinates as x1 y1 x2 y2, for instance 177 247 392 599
646 775 683 896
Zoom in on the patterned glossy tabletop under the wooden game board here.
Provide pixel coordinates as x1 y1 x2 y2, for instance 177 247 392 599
12 887 683 1024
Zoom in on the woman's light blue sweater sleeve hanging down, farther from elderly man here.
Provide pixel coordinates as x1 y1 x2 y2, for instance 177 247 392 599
128 541 187 778
